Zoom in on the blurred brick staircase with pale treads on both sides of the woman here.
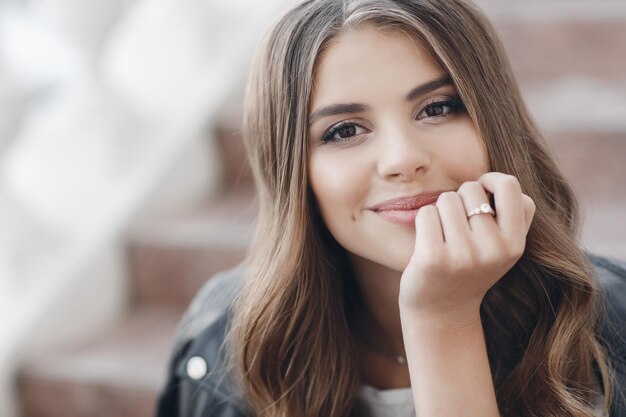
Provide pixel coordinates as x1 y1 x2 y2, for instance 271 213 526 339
17 0 626 417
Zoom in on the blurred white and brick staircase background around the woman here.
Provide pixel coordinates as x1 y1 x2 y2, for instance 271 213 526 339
0 0 626 417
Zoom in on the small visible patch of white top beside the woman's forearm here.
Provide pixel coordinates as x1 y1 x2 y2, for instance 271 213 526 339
357 384 415 417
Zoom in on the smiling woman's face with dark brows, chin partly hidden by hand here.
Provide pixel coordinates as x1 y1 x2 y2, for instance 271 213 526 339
308 26 487 271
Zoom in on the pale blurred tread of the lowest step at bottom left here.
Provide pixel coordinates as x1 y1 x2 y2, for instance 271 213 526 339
20 309 180 393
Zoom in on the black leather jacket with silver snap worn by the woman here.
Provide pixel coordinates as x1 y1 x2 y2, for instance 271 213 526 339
157 256 626 417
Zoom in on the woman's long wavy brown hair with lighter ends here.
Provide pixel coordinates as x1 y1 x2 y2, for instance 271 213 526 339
230 0 611 417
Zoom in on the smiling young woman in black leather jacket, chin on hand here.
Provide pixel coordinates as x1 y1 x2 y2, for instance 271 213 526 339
159 0 626 417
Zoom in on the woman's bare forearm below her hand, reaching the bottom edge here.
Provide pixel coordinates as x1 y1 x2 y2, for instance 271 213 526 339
401 309 499 417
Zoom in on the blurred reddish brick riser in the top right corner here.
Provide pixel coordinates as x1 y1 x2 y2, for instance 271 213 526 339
478 0 626 80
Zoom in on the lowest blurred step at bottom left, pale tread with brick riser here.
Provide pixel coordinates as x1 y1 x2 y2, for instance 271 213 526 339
18 309 180 417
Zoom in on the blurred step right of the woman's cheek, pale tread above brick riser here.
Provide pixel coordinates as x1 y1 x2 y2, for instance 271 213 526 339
522 77 626 203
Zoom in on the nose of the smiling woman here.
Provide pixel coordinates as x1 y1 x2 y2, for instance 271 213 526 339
377 124 431 182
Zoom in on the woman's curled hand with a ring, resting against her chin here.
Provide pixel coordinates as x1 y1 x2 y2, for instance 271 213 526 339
399 172 535 326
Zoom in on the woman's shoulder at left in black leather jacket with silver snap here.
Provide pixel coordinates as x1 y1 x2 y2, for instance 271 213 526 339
157 267 246 417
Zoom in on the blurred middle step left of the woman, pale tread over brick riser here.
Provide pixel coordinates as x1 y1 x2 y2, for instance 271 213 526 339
128 190 257 309
